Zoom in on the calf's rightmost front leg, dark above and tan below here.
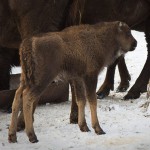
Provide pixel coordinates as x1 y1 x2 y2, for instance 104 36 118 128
85 75 105 135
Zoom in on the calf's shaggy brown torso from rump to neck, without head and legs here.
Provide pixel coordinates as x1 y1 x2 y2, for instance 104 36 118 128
20 22 135 88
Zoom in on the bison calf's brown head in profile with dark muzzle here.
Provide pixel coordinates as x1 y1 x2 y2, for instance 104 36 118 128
116 22 137 53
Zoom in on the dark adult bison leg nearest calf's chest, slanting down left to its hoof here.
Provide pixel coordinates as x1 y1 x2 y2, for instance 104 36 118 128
96 59 118 99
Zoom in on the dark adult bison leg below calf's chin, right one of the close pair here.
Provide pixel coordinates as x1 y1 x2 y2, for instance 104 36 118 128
117 56 131 92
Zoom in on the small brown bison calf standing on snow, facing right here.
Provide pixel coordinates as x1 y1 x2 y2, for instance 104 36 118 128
9 22 136 143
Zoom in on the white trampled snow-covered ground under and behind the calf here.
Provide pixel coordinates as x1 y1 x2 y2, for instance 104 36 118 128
0 31 150 150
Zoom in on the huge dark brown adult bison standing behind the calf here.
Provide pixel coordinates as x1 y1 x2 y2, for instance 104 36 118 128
0 0 150 109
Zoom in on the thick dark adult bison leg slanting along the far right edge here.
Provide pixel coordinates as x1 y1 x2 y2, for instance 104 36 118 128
124 18 150 99
